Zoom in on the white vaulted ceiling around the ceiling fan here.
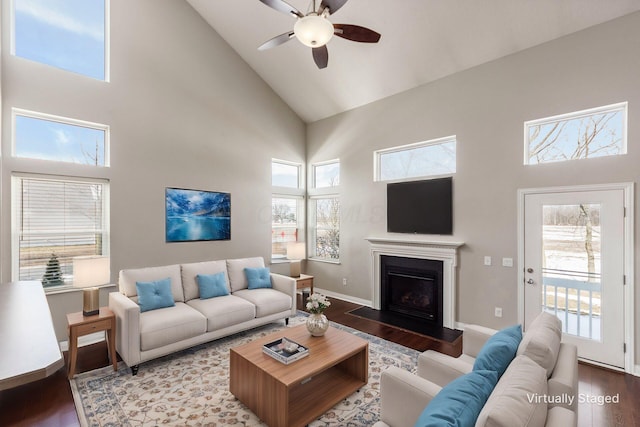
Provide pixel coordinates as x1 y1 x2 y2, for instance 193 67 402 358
188 0 640 123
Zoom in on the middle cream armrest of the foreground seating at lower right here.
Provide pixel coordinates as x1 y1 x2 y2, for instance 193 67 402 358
418 350 474 387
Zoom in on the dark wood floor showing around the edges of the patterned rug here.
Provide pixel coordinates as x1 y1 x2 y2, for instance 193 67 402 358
0 298 640 427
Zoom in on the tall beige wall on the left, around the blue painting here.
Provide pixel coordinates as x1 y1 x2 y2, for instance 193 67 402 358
0 0 305 340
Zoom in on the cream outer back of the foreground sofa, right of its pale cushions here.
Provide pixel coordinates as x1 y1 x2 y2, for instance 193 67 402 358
547 343 578 412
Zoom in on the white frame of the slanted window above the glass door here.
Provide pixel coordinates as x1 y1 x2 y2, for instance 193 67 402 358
523 101 629 166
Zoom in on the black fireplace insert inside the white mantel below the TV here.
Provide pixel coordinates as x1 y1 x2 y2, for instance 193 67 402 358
380 255 443 327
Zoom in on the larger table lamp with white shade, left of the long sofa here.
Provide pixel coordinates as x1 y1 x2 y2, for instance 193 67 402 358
73 256 111 316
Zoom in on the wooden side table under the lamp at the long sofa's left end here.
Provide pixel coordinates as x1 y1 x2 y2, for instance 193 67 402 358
67 307 118 379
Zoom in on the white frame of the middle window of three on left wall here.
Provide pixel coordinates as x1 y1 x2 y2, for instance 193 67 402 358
11 108 111 168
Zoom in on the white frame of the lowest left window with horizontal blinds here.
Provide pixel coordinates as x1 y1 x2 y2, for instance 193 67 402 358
11 172 111 294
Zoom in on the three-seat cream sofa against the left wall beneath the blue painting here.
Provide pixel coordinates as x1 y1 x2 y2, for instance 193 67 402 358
109 257 296 375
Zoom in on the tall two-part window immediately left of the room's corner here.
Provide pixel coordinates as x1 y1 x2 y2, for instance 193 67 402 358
271 160 304 260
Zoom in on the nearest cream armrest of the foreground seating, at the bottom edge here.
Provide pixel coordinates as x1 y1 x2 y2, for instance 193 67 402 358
380 366 442 427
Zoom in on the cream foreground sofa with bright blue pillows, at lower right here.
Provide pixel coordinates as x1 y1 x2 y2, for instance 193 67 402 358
375 312 578 427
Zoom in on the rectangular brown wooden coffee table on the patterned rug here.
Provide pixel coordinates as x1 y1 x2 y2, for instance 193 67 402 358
229 325 369 427
